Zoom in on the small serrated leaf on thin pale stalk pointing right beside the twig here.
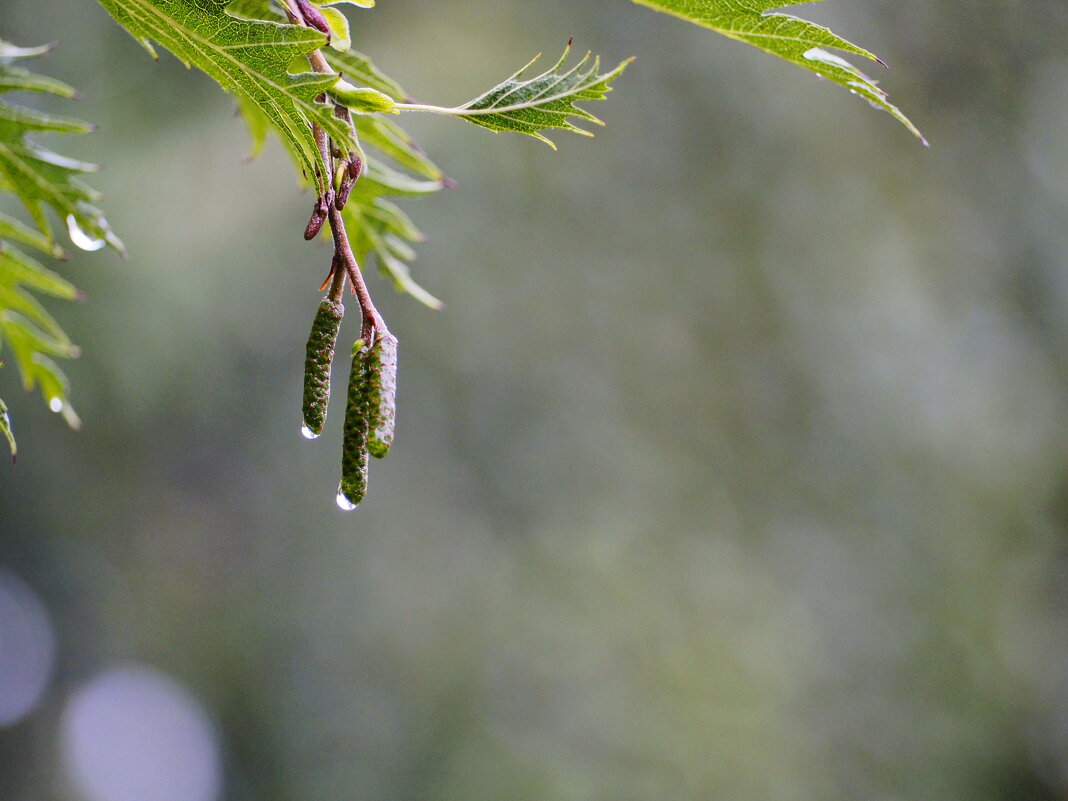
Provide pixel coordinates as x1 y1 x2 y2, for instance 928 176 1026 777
397 42 633 150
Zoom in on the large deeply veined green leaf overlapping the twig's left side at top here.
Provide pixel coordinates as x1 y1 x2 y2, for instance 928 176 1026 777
93 0 356 189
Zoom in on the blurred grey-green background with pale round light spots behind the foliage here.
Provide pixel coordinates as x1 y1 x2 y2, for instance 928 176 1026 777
0 0 1068 801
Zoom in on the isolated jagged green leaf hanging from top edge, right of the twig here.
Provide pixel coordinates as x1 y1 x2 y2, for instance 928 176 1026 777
633 0 927 145
